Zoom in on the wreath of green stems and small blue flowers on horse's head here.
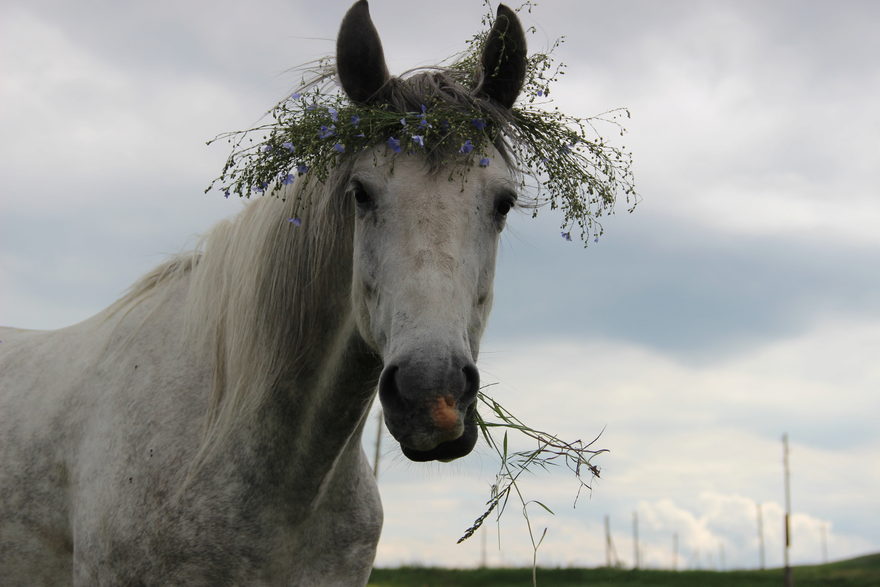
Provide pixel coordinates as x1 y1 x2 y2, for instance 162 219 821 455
205 2 639 246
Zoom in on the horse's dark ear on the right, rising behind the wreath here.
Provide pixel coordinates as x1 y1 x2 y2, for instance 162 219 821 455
477 4 527 108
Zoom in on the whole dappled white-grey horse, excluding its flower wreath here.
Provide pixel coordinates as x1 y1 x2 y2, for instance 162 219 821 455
0 0 525 585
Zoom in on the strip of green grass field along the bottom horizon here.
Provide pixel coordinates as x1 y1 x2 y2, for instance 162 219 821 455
369 554 880 587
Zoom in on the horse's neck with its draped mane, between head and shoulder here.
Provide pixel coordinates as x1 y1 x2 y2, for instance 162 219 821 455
194 180 381 494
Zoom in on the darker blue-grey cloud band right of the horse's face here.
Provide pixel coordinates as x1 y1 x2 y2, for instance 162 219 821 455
490 209 880 362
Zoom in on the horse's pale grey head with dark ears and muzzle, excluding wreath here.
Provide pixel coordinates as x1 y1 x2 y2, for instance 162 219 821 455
337 0 526 461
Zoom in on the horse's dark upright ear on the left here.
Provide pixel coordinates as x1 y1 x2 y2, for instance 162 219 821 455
336 0 389 104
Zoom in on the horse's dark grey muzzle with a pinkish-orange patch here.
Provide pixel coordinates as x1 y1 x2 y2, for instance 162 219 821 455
379 358 480 461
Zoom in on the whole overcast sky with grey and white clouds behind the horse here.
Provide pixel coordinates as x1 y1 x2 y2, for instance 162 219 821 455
0 0 880 568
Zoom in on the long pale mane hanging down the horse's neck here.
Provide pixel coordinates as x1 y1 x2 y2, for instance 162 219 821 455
109 161 353 462
